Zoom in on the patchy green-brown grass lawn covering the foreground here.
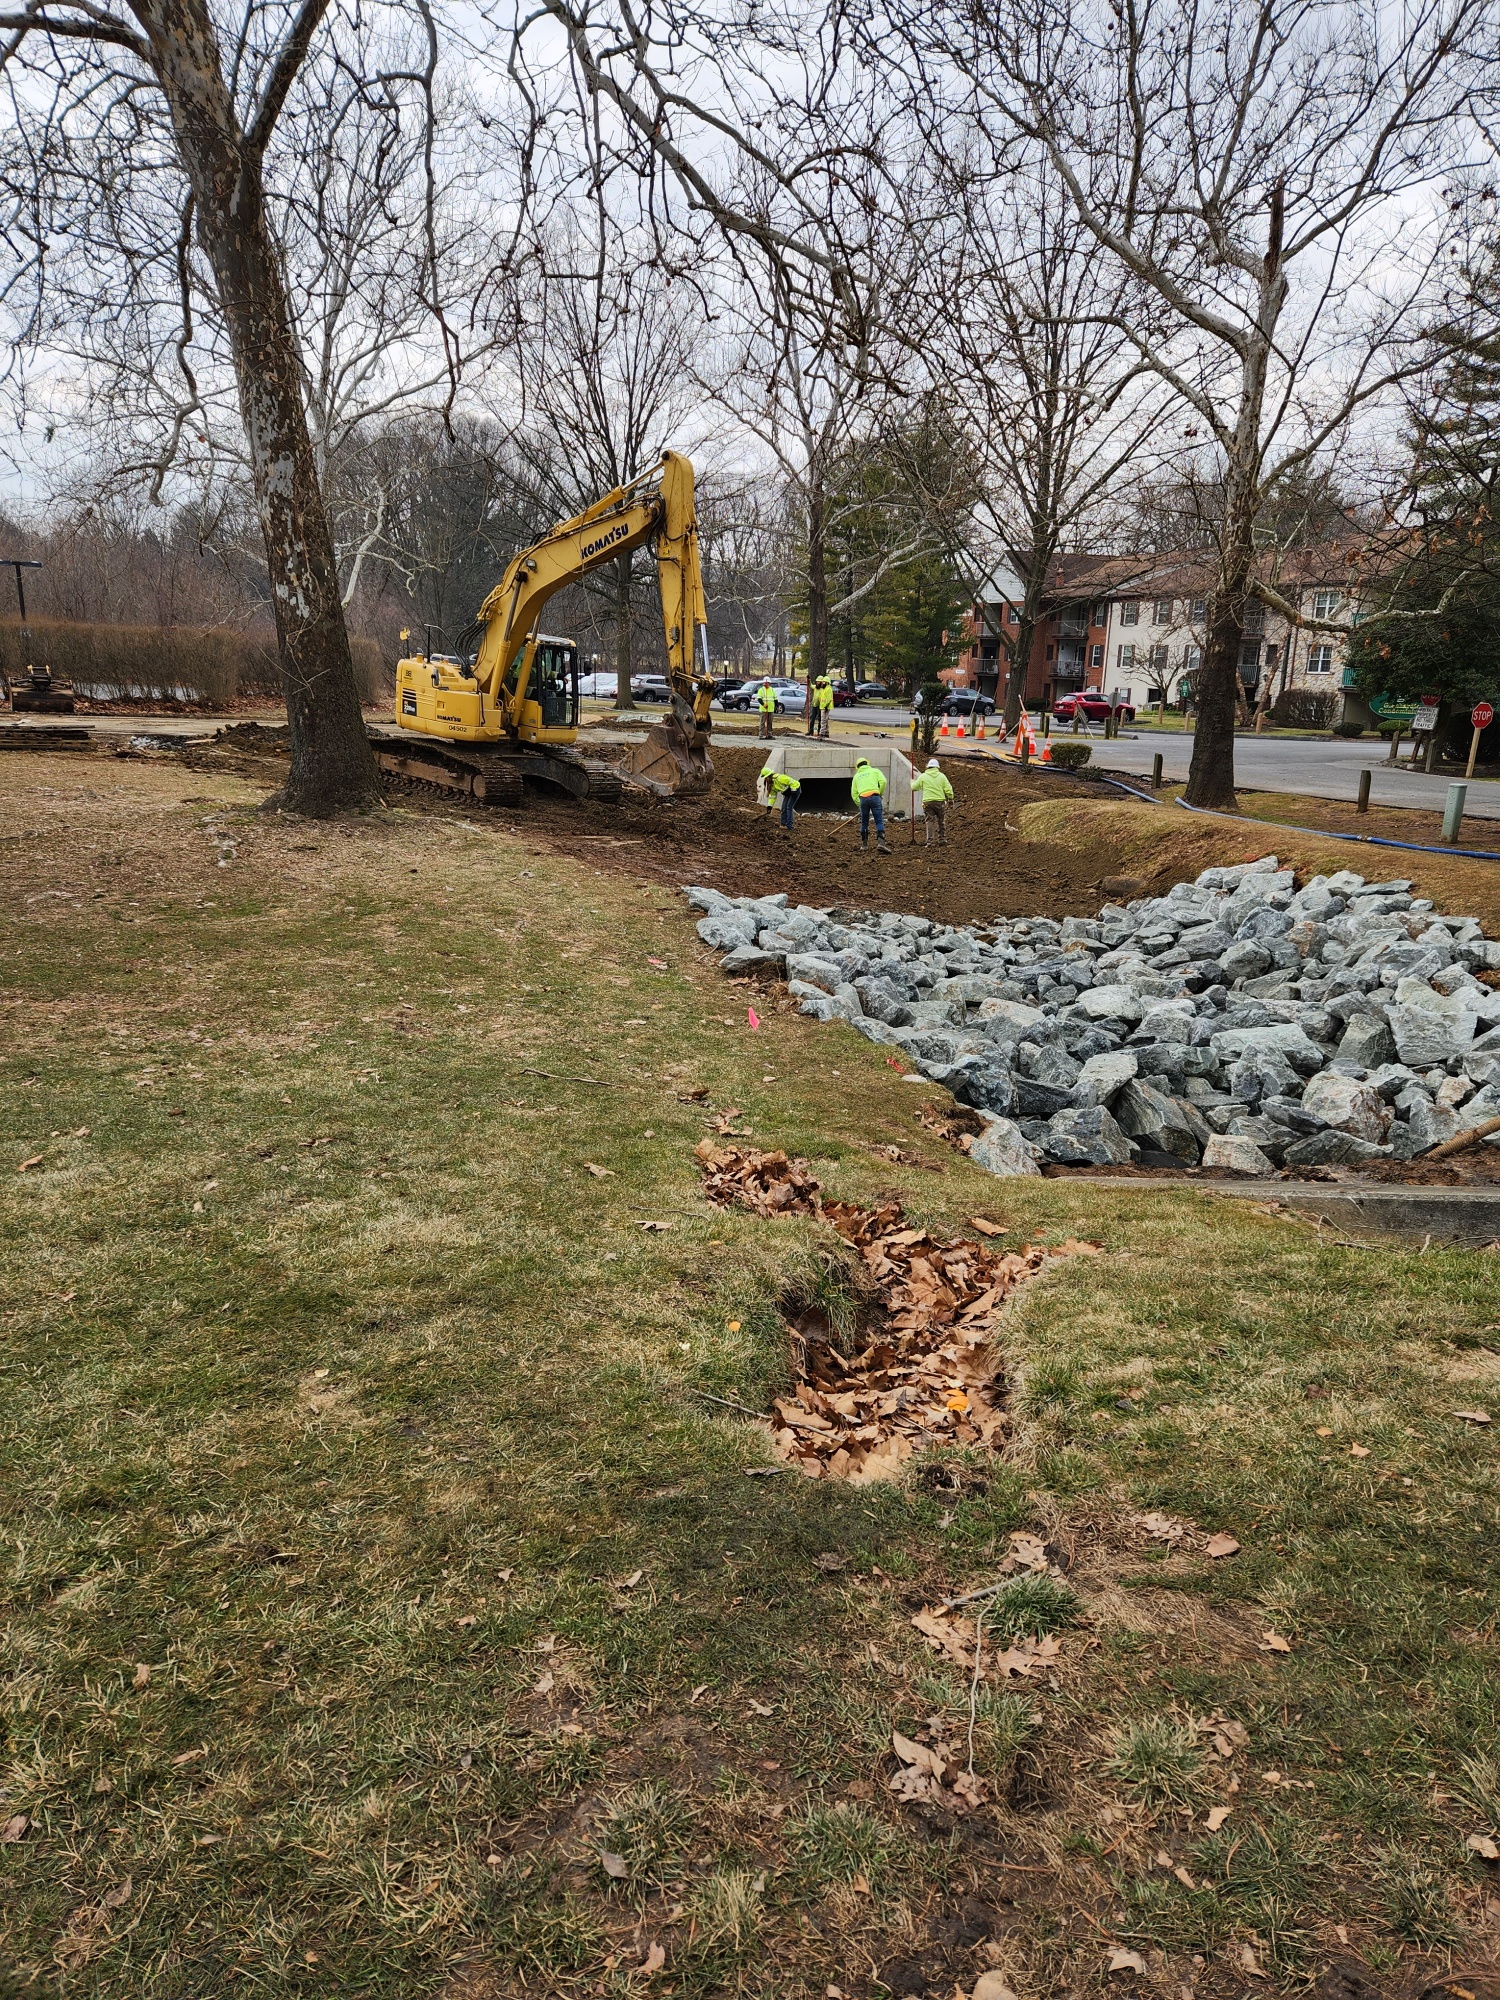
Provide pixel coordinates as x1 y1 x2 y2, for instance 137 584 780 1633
0 758 1500 2000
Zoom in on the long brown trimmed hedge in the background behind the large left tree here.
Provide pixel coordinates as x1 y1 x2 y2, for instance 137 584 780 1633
0 618 390 708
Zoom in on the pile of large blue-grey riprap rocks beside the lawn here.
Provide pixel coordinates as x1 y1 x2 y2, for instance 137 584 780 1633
686 854 1500 1174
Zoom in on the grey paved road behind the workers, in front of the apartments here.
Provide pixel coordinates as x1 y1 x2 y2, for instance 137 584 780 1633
840 706 1500 820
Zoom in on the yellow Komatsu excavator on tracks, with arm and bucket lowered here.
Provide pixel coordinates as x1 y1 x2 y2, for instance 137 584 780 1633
370 452 714 806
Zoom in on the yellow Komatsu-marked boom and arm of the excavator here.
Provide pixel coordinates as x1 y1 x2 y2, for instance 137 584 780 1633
474 452 712 756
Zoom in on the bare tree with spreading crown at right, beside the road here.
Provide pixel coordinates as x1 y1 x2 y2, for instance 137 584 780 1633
908 0 1494 806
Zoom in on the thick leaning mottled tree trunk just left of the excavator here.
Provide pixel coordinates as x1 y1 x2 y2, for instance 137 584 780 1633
138 0 380 816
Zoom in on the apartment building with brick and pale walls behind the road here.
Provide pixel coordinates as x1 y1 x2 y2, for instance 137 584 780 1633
964 546 1350 710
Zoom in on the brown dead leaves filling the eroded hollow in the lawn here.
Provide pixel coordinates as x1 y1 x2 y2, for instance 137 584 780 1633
698 1140 1096 1482
